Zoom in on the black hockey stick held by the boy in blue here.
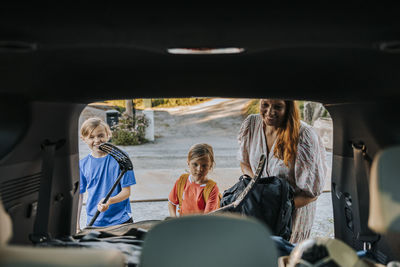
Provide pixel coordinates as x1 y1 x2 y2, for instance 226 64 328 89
88 143 133 226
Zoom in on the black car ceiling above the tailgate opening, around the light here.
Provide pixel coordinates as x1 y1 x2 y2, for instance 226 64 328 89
0 4 400 104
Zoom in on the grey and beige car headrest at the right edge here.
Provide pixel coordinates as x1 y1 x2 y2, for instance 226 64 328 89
368 146 400 233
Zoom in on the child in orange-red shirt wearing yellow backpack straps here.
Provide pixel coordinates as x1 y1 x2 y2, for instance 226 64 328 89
168 144 219 217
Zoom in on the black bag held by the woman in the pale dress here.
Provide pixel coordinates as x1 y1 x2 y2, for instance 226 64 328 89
221 175 294 240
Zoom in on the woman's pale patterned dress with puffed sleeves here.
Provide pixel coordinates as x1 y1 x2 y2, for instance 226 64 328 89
238 114 328 243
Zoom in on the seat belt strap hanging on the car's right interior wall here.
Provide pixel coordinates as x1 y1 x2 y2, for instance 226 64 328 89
352 143 380 251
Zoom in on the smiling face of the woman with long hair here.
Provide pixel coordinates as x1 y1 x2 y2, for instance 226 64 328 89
260 99 286 127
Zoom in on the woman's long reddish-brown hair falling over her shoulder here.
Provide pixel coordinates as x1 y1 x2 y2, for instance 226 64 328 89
274 100 300 167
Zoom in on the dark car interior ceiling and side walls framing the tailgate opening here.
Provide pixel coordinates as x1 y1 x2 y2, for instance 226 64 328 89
0 3 400 262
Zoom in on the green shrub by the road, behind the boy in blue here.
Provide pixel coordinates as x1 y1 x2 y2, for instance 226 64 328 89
111 114 149 146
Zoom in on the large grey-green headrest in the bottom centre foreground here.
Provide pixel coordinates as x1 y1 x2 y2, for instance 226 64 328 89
140 215 278 267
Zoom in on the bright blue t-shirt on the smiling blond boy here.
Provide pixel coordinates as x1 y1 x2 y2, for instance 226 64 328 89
79 154 136 226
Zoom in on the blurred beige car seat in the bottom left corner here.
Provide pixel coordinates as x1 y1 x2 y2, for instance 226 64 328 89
0 196 125 267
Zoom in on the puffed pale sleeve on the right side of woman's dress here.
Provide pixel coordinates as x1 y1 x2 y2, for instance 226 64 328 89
294 124 327 197
